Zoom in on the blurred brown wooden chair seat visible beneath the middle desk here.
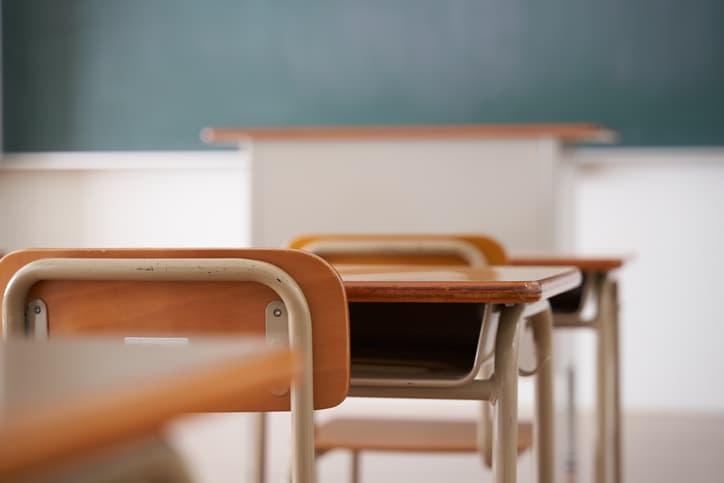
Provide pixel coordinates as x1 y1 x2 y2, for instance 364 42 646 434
314 418 533 454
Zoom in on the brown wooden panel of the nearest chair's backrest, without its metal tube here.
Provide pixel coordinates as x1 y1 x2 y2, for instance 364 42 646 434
0 249 350 411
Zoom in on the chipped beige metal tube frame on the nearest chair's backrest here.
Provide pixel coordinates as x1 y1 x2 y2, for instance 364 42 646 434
2 258 314 483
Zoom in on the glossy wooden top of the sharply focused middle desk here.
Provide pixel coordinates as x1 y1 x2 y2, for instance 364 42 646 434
335 265 581 303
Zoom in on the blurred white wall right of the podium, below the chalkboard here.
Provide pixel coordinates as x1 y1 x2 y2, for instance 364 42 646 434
573 149 724 411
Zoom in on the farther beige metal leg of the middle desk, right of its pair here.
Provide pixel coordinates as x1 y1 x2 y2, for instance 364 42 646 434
530 307 555 483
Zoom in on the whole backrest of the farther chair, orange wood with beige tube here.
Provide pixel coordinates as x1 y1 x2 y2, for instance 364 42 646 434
289 234 508 266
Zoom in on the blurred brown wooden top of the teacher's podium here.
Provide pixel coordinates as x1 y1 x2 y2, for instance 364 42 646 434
201 123 616 144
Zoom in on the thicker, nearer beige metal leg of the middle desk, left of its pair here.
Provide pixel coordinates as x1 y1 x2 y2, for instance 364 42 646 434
493 305 523 483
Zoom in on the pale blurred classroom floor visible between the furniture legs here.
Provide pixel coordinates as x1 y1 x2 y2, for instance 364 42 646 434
172 413 724 483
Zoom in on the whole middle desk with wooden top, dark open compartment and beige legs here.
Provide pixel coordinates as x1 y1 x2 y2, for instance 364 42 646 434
335 265 581 483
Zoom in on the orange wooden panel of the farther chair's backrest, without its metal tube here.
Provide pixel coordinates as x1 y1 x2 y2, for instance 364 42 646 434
289 234 508 265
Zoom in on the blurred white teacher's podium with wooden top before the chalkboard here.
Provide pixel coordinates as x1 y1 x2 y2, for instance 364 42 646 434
202 124 614 252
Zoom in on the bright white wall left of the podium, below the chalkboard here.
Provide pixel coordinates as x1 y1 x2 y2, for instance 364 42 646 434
0 151 250 251
